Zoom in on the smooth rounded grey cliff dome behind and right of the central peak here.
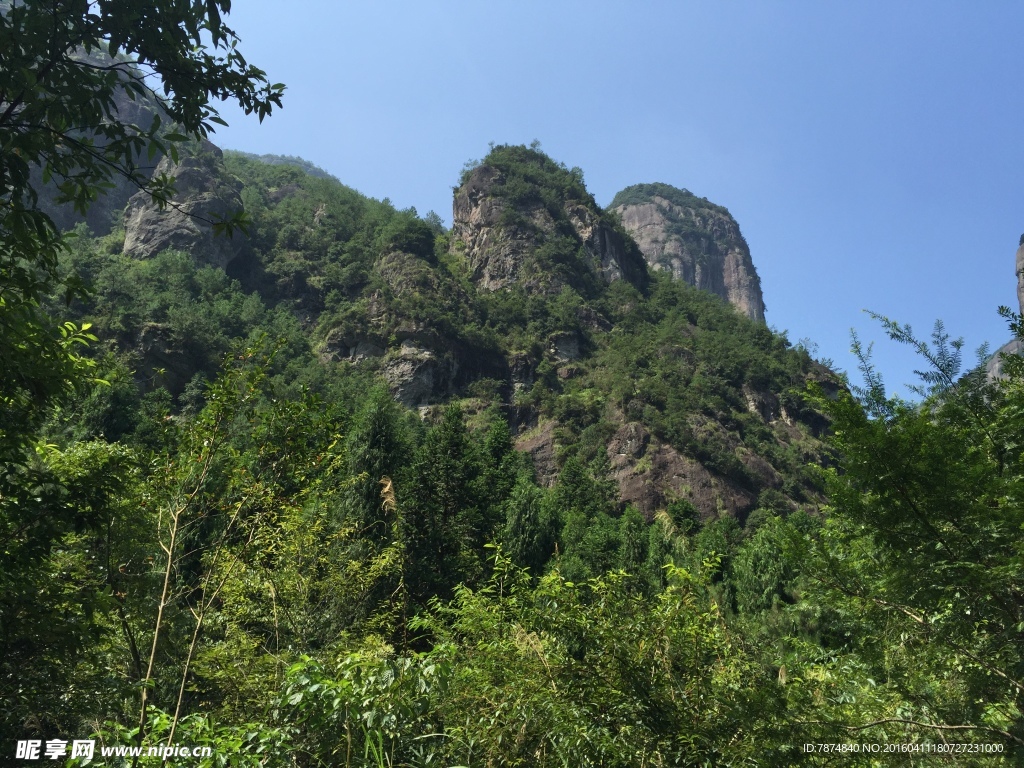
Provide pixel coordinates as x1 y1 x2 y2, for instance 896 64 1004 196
610 184 765 322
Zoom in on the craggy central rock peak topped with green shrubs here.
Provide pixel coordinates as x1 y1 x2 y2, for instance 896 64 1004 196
452 147 647 295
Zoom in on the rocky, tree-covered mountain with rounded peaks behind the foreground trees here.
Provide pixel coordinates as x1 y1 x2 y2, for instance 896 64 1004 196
56 140 840 519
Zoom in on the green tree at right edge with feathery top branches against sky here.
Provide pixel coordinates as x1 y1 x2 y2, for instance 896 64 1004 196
805 321 1024 749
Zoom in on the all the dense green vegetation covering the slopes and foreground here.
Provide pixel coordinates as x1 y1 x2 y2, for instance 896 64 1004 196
0 7 1024 766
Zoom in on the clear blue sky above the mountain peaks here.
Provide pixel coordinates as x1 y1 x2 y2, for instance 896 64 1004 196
214 0 1024 394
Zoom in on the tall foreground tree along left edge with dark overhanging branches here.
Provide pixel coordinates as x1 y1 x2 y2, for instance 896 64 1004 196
0 20 284 740
